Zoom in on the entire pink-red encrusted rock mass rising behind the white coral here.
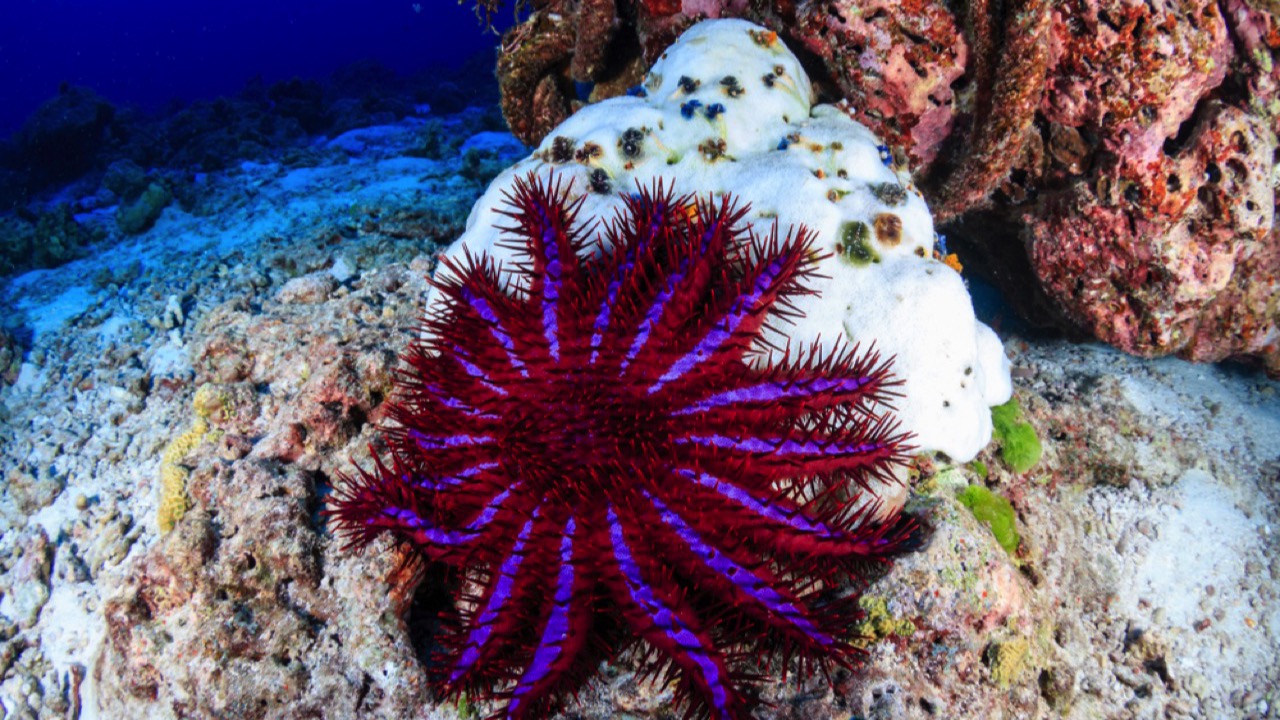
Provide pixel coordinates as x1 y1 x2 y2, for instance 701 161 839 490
489 0 1280 374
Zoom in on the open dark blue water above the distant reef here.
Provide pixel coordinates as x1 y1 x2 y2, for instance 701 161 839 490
0 0 511 138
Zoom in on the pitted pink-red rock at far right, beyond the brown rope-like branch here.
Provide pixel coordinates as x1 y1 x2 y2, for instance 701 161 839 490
997 0 1280 374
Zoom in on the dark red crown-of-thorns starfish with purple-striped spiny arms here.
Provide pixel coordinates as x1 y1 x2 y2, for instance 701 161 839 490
329 174 915 719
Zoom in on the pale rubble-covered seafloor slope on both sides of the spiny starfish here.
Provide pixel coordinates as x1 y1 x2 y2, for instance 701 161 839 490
0 103 1280 719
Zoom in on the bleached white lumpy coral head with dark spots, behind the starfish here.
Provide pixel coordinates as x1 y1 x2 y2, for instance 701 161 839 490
448 19 1012 461
